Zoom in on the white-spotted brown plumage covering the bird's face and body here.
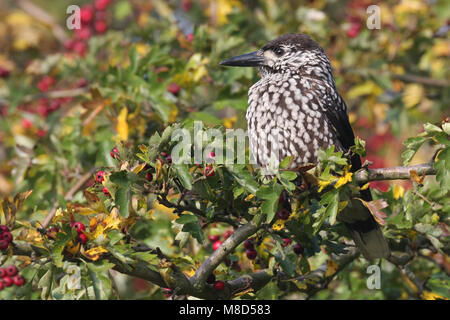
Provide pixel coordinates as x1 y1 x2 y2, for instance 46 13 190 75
246 35 346 168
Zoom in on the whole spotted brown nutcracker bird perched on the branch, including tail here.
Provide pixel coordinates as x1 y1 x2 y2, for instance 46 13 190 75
220 34 390 260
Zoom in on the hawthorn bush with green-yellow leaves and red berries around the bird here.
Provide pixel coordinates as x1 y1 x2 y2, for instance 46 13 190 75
0 0 450 300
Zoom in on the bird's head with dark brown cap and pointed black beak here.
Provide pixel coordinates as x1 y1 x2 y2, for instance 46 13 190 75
220 34 331 77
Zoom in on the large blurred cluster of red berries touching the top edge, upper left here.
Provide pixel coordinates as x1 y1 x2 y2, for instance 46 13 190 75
64 0 111 56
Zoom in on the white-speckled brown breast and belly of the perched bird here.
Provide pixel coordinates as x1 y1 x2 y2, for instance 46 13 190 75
246 76 338 168
